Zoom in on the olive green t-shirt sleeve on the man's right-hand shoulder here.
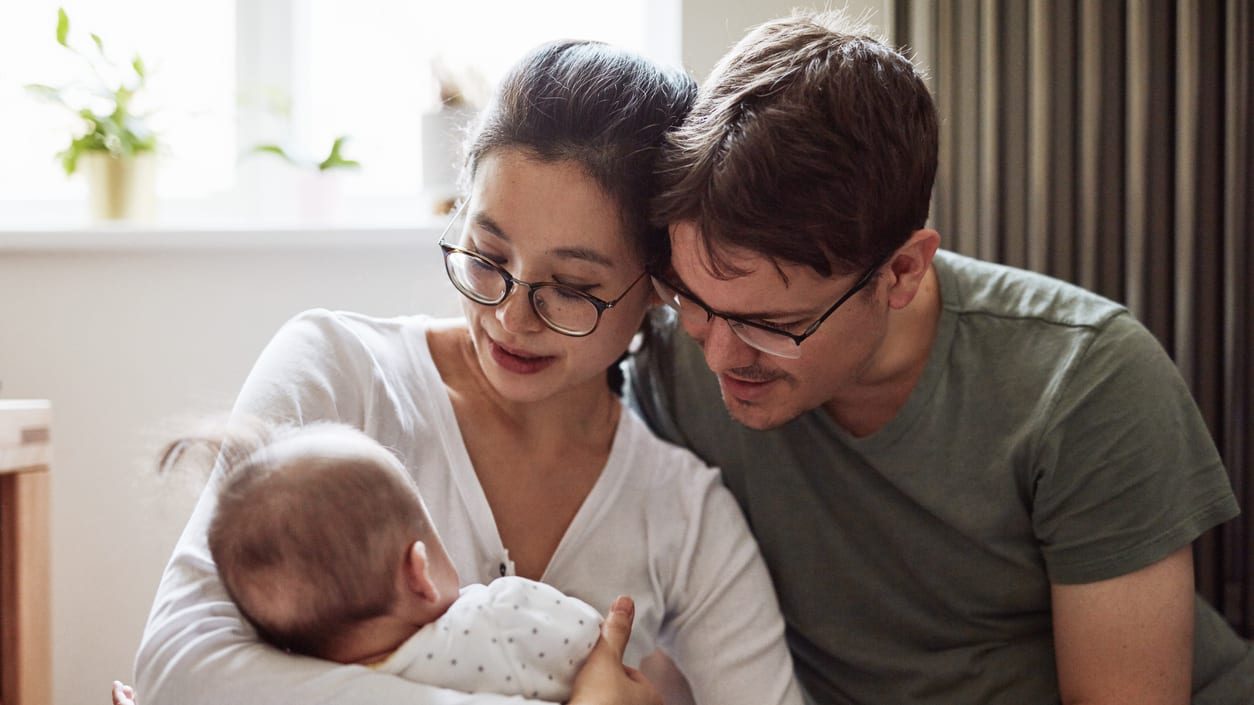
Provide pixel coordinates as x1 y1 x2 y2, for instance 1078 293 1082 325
1032 312 1239 583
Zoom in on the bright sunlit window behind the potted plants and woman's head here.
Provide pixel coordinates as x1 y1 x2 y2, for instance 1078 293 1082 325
0 0 680 227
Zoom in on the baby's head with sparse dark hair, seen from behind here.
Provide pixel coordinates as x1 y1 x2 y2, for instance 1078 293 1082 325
168 424 459 662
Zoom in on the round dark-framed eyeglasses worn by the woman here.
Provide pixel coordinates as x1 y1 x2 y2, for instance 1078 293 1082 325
440 203 647 337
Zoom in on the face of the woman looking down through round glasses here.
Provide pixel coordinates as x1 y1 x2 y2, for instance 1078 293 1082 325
446 149 651 401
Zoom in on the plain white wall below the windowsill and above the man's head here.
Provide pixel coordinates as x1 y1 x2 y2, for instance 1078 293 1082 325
0 0 887 705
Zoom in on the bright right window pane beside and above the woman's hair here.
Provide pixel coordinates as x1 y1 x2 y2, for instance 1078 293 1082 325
305 0 647 197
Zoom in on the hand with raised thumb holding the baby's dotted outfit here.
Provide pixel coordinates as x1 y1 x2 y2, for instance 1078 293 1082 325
571 596 662 705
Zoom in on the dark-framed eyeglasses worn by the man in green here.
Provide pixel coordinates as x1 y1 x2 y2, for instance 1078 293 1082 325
651 257 889 360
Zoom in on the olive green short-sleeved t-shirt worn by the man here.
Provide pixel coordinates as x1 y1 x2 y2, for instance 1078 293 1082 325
628 251 1254 705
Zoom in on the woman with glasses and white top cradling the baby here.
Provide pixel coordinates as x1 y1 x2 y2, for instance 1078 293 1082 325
137 43 800 705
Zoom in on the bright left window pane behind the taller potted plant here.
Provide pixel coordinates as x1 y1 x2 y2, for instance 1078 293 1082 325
0 0 236 199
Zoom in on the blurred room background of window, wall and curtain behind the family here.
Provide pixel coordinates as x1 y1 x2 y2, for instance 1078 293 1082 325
0 0 1254 705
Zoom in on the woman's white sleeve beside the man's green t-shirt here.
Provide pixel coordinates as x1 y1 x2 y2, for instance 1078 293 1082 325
661 452 801 705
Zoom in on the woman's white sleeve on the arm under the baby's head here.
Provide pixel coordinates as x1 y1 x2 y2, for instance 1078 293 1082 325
135 311 549 705
